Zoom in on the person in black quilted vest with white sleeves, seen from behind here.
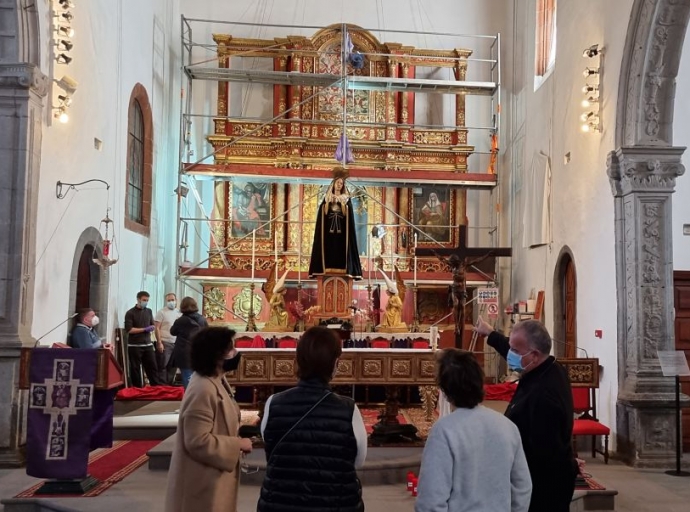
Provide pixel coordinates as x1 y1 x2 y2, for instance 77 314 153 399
257 327 367 512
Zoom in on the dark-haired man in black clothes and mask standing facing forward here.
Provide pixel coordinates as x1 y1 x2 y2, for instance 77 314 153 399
125 291 160 388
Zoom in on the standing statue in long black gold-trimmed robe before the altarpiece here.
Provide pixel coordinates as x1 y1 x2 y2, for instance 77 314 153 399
309 168 362 280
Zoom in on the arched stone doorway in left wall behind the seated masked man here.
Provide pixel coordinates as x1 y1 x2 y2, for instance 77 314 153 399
67 227 110 336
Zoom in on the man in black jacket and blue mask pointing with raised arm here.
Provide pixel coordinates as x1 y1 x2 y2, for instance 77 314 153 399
475 318 578 512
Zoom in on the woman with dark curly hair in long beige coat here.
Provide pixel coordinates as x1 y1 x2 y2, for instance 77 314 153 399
165 327 252 512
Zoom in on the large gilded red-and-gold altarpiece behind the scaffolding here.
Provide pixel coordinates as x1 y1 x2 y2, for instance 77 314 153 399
183 24 496 331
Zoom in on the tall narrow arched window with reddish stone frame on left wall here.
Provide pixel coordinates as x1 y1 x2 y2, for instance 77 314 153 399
125 84 153 235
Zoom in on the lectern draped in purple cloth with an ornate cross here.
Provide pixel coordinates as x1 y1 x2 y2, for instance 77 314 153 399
19 344 124 495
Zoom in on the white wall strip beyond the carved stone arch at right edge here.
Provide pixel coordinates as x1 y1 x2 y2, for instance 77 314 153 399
672 35 690 270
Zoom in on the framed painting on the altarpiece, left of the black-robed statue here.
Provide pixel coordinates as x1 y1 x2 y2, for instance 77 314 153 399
229 179 273 240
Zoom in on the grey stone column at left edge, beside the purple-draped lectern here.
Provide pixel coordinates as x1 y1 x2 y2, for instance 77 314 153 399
0 63 49 467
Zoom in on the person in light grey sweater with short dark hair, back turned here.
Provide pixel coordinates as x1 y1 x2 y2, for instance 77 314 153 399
415 348 532 512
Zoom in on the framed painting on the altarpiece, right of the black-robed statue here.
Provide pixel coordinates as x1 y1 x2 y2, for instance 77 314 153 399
410 185 455 245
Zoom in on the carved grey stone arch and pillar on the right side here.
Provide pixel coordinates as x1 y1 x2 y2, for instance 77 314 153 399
607 0 690 467
